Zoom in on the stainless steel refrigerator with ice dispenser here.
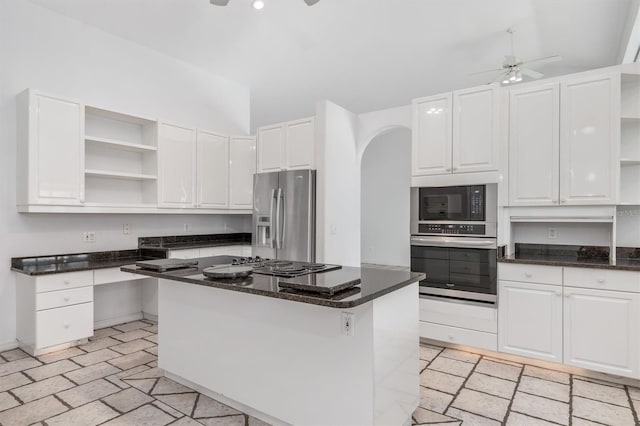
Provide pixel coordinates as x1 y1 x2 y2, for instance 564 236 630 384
252 170 316 262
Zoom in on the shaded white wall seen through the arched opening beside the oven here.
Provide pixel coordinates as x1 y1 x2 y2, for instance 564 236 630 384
360 129 411 266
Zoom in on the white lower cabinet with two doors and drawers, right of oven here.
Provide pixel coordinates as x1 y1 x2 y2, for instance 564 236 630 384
498 264 640 379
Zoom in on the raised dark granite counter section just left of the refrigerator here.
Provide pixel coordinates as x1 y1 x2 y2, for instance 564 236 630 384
138 232 251 251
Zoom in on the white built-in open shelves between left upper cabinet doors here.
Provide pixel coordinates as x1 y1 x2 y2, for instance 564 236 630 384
85 106 158 208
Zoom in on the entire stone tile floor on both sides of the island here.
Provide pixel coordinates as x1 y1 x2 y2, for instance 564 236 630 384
0 321 640 426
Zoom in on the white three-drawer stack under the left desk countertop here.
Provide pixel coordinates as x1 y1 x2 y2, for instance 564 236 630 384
16 271 93 355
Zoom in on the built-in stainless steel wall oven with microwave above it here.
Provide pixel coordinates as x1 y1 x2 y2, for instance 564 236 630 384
411 184 497 303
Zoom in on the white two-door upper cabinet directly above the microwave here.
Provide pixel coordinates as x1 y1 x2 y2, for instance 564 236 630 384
412 84 500 176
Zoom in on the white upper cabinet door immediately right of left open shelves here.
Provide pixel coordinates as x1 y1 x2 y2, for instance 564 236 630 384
158 123 197 208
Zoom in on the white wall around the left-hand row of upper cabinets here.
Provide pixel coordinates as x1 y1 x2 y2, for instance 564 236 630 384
0 0 250 346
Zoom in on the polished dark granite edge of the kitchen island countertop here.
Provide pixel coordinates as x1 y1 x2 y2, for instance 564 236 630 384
120 265 425 309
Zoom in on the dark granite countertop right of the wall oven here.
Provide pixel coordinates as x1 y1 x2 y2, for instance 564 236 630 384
498 244 640 271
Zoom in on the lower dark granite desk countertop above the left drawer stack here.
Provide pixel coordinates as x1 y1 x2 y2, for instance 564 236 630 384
11 249 164 275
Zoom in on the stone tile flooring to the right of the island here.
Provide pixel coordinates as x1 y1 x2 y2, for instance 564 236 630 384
413 345 640 426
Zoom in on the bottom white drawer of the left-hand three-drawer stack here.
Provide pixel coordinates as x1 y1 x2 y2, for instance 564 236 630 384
36 302 93 348
